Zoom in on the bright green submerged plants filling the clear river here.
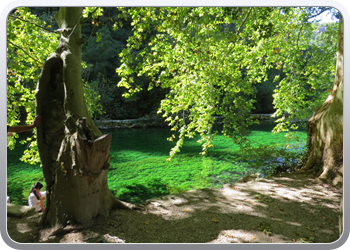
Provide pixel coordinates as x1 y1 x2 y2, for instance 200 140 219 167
7 123 307 204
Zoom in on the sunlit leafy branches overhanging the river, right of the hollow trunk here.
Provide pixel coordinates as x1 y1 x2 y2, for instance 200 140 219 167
117 7 335 158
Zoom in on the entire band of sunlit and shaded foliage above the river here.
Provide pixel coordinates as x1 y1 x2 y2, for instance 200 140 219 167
7 7 338 163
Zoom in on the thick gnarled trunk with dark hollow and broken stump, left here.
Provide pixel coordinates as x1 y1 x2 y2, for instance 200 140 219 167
36 7 126 229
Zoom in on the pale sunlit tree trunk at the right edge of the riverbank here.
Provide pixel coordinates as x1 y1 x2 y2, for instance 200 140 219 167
304 19 344 186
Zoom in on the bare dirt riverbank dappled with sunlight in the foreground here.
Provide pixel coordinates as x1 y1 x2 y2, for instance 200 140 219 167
7 171 342 243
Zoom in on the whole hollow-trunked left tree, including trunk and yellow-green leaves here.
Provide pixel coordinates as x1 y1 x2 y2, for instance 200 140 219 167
8 7 129 228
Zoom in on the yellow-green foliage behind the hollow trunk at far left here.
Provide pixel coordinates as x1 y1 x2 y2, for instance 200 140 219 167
7 7 101 164
